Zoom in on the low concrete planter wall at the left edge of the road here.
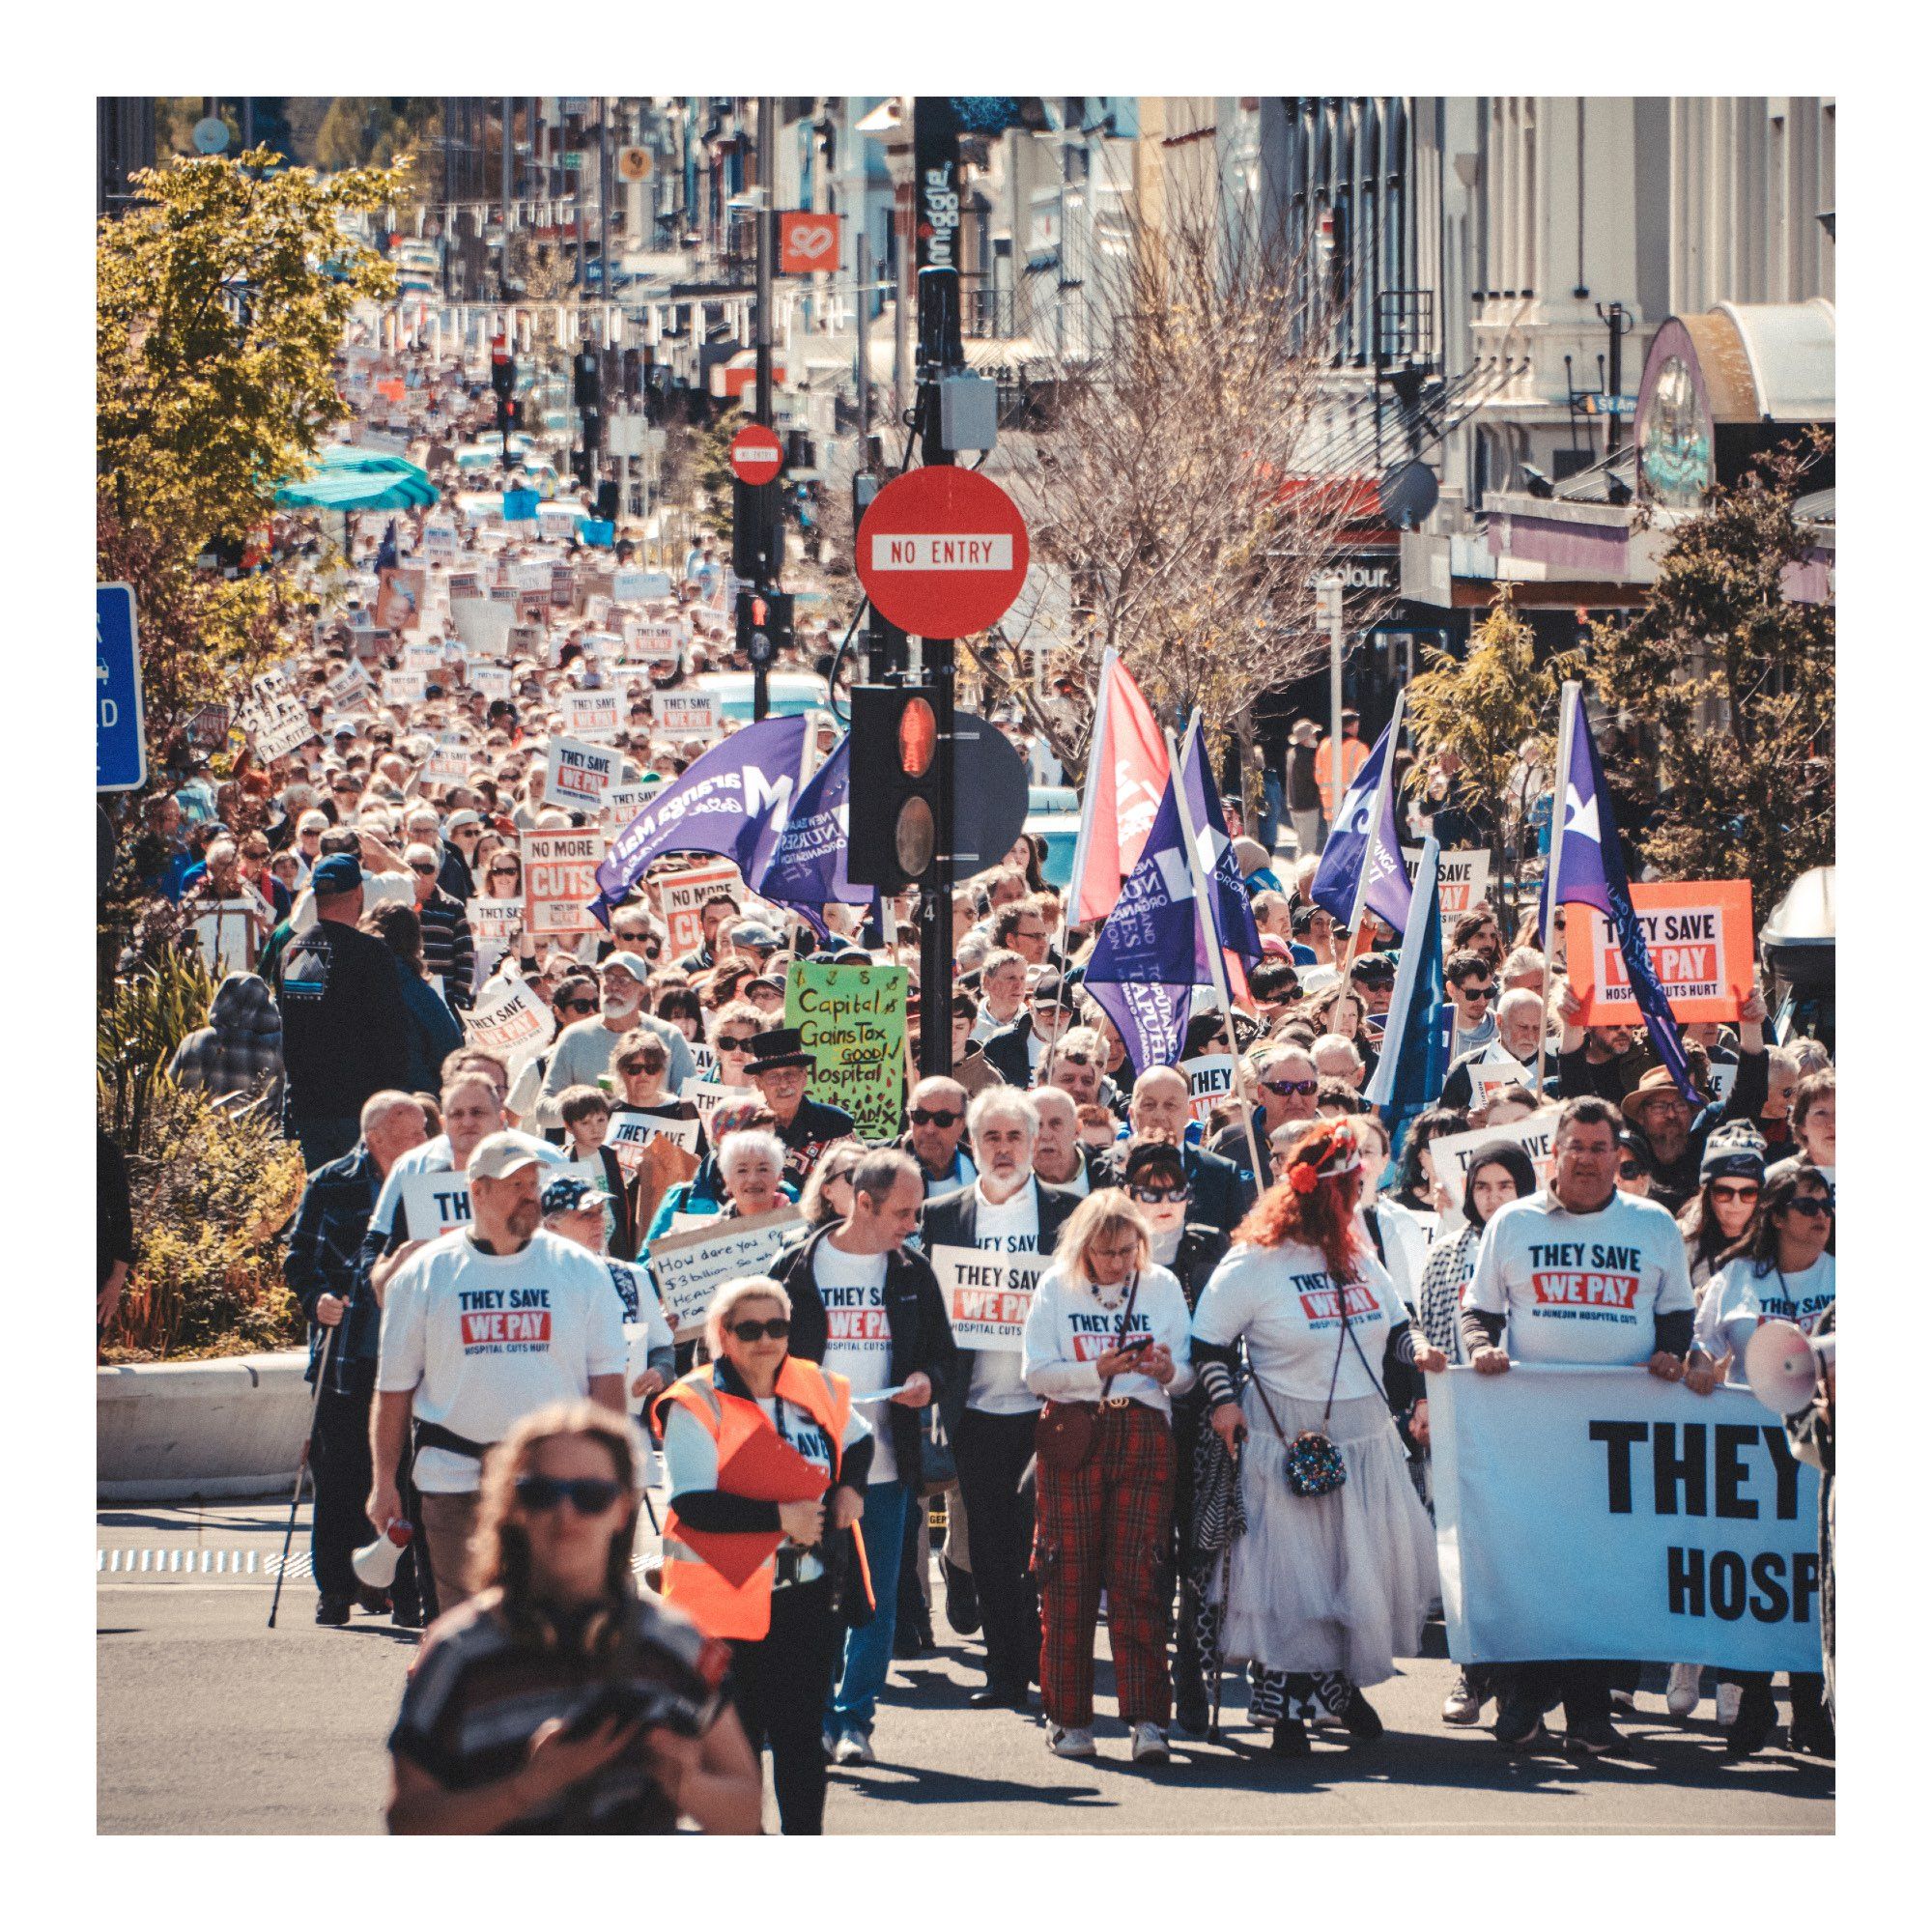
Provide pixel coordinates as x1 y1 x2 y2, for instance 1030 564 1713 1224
95 1349 311 1503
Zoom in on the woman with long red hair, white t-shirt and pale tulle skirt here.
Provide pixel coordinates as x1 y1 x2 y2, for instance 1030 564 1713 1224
1192 1119 1447 1758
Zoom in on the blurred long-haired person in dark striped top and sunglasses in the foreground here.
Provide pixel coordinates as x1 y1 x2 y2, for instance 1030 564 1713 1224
388 1403 761 1833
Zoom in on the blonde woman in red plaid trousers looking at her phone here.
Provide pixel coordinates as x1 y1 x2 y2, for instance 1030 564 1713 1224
1020 1188 1194 1764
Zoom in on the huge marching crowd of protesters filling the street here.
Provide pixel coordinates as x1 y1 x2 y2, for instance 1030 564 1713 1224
102 317 1835 1833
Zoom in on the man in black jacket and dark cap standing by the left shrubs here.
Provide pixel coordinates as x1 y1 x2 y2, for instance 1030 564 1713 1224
276 852 410 1169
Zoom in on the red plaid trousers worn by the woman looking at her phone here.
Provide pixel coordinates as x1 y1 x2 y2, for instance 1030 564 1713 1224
1034 1403 1175 1725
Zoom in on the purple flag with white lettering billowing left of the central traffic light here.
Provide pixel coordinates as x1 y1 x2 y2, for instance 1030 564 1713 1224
591 717 810 925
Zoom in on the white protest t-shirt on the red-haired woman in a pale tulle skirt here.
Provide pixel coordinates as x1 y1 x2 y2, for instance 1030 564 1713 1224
1194 1240 1408 1403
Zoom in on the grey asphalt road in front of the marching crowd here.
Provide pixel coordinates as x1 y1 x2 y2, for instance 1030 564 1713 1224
97 1503 1833 1835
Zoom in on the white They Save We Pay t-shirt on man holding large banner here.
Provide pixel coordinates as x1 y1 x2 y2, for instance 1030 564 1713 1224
1463 1194 1696 1366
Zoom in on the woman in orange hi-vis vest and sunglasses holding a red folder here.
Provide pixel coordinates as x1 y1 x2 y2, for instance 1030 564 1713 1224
659 1275 871 1837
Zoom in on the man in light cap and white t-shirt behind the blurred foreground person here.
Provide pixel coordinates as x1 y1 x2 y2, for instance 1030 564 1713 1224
369 1134 628 1609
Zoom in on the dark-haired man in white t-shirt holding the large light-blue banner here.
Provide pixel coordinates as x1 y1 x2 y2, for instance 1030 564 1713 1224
1463 1094 1696 1756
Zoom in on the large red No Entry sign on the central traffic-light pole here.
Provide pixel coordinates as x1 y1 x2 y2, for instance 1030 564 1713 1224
858 464 1028 638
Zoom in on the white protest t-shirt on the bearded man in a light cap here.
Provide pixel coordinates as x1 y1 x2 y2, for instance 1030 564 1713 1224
375 1229 628 1495
